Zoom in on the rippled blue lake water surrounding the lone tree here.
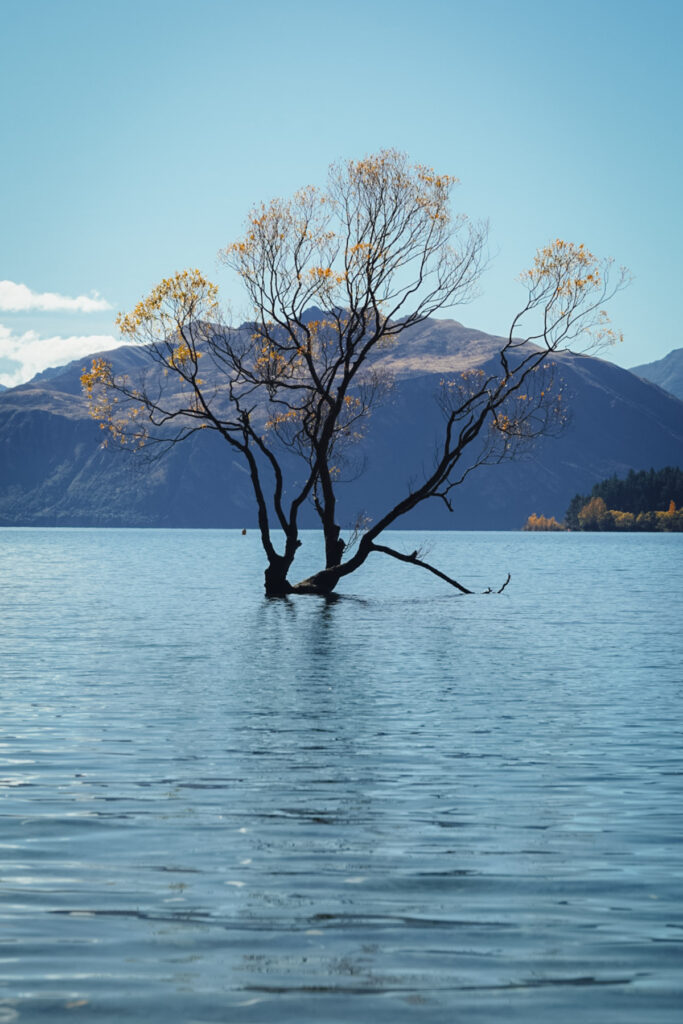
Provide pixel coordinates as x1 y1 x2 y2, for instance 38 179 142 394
0 529 683 1024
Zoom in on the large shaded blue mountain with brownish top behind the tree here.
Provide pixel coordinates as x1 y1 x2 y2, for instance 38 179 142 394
0 321 683 529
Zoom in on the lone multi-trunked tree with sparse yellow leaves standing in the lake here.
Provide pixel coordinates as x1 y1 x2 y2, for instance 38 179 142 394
82 151 627 597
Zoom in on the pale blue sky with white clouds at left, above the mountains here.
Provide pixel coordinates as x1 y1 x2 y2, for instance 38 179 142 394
0 0 683 384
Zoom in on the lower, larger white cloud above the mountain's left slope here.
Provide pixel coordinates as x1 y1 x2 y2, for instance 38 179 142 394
0 324 121 387
